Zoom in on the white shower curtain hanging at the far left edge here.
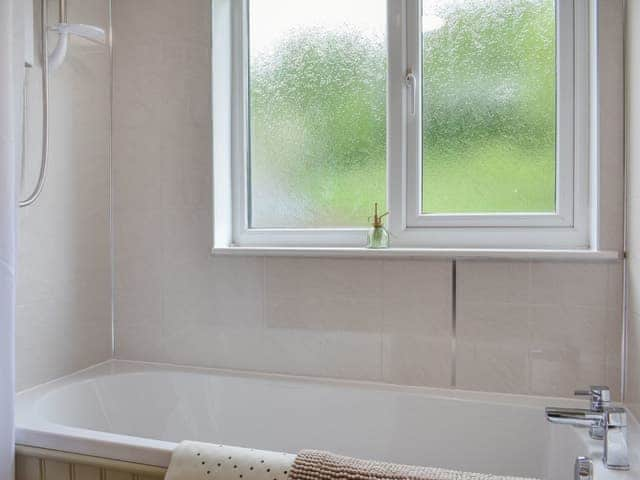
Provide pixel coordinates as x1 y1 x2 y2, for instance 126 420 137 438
0 0 23 480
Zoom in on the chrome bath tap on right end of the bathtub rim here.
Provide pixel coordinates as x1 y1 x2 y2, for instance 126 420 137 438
545 386 629 470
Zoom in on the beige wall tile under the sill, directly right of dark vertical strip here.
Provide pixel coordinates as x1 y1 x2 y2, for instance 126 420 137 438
456 260 531 303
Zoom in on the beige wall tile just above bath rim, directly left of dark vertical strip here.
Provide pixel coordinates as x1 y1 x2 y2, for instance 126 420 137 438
382 333 453 387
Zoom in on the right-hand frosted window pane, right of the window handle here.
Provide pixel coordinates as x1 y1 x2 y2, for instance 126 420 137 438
422 0 556 213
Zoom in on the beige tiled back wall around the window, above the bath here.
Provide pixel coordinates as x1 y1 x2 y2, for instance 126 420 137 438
113 0 622 395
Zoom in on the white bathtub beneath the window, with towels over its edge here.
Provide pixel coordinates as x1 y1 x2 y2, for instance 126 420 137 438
16 360 640 480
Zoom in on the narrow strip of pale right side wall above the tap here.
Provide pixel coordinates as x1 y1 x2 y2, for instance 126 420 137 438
625 1 640 418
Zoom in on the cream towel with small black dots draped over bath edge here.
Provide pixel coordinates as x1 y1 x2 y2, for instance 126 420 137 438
165 442 295 480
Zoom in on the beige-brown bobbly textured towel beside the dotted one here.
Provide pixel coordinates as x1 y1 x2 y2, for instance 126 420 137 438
289 450 533 480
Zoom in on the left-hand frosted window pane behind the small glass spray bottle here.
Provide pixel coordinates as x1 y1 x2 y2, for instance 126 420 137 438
249 0 386 228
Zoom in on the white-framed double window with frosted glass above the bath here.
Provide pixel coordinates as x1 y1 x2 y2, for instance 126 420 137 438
214 0 590 248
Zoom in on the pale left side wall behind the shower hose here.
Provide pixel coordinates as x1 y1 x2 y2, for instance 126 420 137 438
16 0 111 390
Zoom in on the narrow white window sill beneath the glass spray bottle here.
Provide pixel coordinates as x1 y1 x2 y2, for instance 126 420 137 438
212 247 620 261
